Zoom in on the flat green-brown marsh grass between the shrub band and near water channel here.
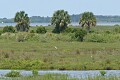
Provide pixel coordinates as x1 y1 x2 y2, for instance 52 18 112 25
0 41 120 70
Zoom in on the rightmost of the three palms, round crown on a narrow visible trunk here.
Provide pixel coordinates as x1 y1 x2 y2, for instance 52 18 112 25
79 12 96 32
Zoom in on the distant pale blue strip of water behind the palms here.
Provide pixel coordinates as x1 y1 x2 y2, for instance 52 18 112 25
0 22 120 27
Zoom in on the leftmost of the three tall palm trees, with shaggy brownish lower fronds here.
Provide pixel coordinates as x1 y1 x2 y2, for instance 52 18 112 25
14 11 30 32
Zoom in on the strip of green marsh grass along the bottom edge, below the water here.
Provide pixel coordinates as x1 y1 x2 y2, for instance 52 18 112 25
0 74 120 80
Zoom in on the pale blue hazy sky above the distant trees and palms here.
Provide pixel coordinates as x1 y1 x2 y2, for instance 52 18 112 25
0 0 120 18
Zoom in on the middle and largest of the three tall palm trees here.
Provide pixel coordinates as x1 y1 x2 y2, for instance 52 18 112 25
51 10 70 33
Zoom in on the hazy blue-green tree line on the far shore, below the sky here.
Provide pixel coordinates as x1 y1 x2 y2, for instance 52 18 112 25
0 14 120 23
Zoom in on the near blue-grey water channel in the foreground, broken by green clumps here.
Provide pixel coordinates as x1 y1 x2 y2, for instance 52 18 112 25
0 70 120 78
